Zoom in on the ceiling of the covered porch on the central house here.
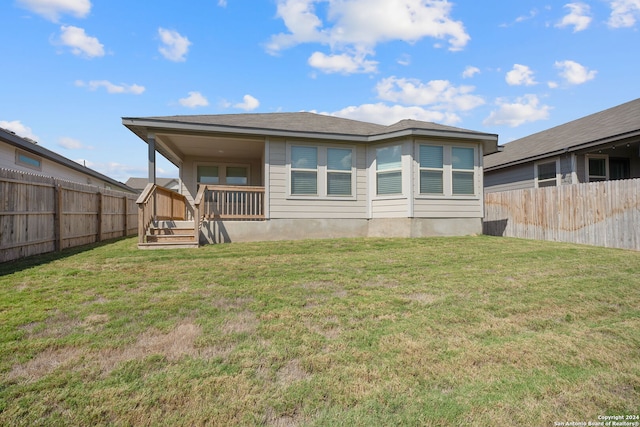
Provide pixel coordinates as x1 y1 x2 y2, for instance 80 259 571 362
155 132 264 161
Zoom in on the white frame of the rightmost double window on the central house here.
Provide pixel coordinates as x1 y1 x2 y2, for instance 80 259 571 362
414 141 481 200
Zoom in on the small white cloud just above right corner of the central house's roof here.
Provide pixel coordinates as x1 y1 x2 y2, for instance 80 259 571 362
482 95 551 127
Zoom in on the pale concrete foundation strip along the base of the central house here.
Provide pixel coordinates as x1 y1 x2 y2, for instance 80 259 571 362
200 218 482 244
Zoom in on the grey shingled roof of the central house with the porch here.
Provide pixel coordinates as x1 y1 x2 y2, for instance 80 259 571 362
122 112 498 145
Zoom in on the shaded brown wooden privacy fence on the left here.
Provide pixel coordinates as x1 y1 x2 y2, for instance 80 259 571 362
0 169 138 262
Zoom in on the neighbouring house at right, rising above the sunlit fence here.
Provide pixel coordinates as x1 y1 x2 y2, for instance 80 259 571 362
484 98 640 192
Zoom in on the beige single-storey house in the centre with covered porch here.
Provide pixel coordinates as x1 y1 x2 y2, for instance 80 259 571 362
122 112 498 247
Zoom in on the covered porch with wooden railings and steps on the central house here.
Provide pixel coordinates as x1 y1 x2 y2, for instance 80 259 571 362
130 122 268 249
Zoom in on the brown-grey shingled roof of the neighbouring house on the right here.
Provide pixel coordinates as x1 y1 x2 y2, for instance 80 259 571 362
484 98 640 171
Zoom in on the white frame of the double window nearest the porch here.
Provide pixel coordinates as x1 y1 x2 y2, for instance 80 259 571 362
286 141 357 200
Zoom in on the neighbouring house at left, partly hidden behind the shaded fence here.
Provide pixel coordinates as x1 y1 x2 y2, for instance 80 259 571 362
0 128 135 193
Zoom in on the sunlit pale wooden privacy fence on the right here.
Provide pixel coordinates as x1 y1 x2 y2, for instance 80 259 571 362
483 179 640 250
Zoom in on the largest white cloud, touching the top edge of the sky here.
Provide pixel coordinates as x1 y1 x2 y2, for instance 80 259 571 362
266 0 470 72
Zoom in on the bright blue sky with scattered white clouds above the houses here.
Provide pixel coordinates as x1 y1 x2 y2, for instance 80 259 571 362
0 0 640 181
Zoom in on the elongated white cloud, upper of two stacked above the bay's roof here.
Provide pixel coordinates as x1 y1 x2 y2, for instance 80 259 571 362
376 76 484 111
